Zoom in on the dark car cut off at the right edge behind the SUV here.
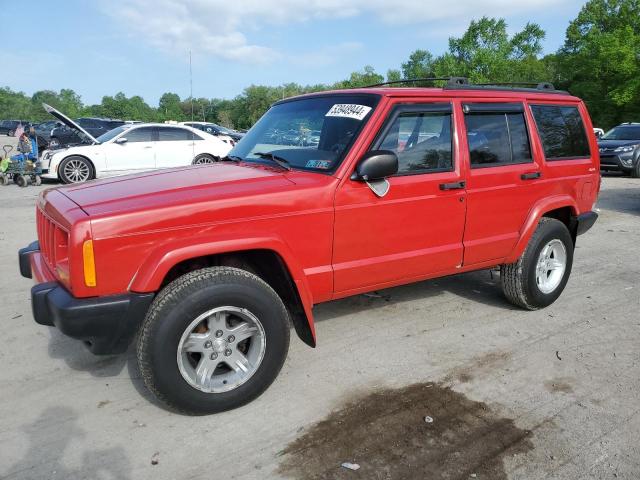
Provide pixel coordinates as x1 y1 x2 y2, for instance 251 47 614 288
598 123 640 178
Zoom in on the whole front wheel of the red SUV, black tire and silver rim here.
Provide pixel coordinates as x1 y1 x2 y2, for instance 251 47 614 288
137 267 290 414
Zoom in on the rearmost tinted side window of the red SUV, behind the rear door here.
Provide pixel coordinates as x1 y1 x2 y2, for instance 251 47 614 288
531 105 590 160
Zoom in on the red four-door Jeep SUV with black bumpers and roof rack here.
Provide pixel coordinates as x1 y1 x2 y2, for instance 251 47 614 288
19 79 600 413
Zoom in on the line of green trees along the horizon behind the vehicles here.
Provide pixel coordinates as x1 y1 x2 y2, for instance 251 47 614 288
0 0 640 129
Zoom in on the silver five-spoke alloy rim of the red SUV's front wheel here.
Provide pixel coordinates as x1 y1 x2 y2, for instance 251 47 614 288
177 306 266 393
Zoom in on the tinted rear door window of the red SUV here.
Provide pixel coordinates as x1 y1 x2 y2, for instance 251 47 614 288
464 104 533 168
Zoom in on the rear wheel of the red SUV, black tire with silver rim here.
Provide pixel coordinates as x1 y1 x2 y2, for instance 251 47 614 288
500 217 574 310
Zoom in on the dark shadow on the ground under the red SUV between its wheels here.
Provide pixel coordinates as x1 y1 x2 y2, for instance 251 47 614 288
314 270 519 322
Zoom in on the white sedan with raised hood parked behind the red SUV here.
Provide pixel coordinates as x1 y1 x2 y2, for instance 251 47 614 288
42 122 232 183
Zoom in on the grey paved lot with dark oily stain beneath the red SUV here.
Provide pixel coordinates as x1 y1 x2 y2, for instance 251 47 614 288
0 173 640 479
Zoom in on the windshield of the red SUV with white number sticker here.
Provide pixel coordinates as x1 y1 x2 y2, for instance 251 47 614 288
229 94 379 173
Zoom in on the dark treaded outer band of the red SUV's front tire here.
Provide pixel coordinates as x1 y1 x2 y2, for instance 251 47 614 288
136 267 291 415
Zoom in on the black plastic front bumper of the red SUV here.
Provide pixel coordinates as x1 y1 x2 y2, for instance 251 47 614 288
18 242 154 355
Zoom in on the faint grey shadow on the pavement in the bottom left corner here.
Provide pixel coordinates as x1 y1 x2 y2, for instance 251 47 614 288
0 406 131 480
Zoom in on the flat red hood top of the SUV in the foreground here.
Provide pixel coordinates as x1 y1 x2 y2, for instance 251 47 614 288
59 162 294 216
